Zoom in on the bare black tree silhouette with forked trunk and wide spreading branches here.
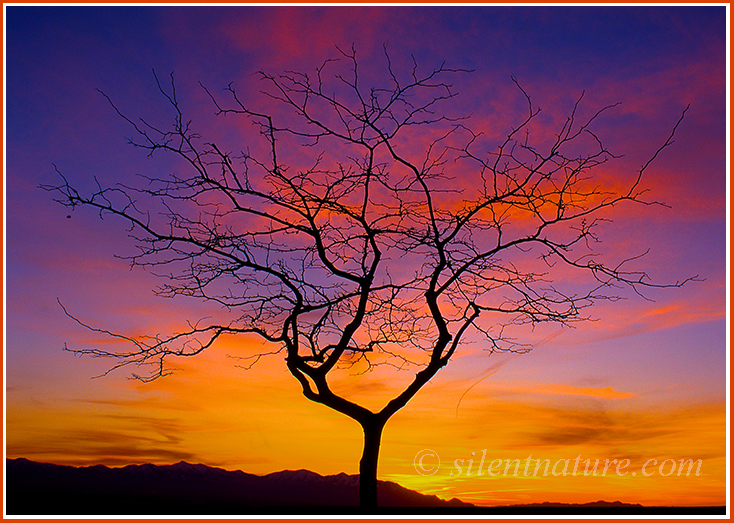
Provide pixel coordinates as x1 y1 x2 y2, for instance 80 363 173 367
43 49 685 507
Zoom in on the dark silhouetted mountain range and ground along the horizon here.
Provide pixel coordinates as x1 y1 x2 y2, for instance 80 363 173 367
5 458 726 516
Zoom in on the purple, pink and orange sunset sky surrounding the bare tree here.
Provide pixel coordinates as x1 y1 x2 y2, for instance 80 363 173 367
4 6 728 505
